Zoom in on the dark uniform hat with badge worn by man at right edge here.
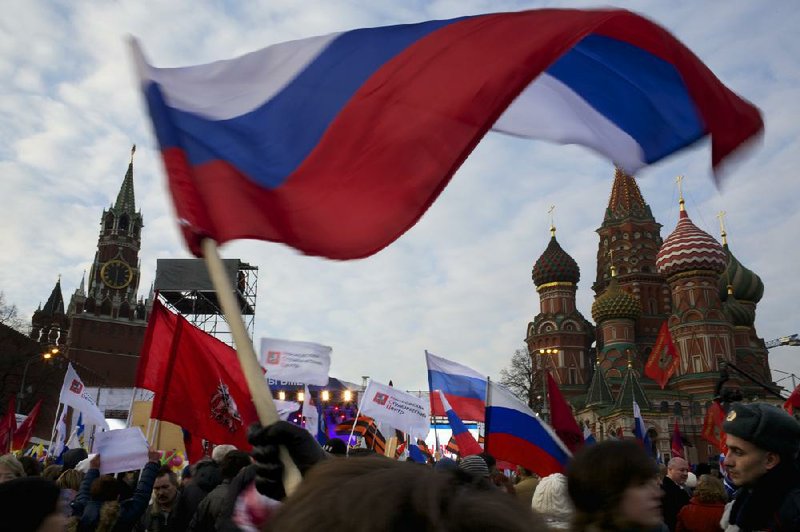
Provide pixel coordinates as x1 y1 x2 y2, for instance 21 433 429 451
722 403 800 455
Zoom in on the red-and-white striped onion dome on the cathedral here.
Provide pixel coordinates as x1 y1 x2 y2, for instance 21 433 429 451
656 208 728 277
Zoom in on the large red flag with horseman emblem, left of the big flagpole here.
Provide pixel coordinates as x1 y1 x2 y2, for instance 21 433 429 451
136 300 258 449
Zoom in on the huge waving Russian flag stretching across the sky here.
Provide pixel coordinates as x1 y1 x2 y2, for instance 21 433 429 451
133 9 763 259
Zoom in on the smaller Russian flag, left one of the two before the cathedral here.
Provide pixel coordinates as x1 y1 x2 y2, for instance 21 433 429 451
425 351 486 421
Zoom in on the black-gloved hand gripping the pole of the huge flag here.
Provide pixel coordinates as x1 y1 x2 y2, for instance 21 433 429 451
247 421 326 500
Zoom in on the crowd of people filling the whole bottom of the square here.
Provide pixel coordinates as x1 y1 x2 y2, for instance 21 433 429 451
0 403 800 532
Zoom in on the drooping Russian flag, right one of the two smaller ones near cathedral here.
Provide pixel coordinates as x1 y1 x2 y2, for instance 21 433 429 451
485 382 572 477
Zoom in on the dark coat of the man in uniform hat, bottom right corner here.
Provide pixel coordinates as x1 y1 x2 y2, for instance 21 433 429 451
723 462 800 532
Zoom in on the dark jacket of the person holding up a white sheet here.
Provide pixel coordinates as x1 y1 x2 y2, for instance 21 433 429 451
71 462 159 532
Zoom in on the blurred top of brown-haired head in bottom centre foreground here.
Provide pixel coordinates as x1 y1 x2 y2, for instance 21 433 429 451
265 450 546 532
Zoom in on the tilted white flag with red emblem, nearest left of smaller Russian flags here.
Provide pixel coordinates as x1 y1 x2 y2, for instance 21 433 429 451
361 381 431 439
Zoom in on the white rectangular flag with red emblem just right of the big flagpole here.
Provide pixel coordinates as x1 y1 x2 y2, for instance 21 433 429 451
259 338 332 386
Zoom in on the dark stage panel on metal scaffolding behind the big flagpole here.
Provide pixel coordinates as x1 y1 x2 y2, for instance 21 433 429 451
153 259 258 346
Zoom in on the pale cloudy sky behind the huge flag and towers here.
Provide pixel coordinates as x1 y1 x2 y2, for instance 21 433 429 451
0 0 800 389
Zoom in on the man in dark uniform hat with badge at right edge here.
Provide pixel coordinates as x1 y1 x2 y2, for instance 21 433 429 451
720 403 800 532
